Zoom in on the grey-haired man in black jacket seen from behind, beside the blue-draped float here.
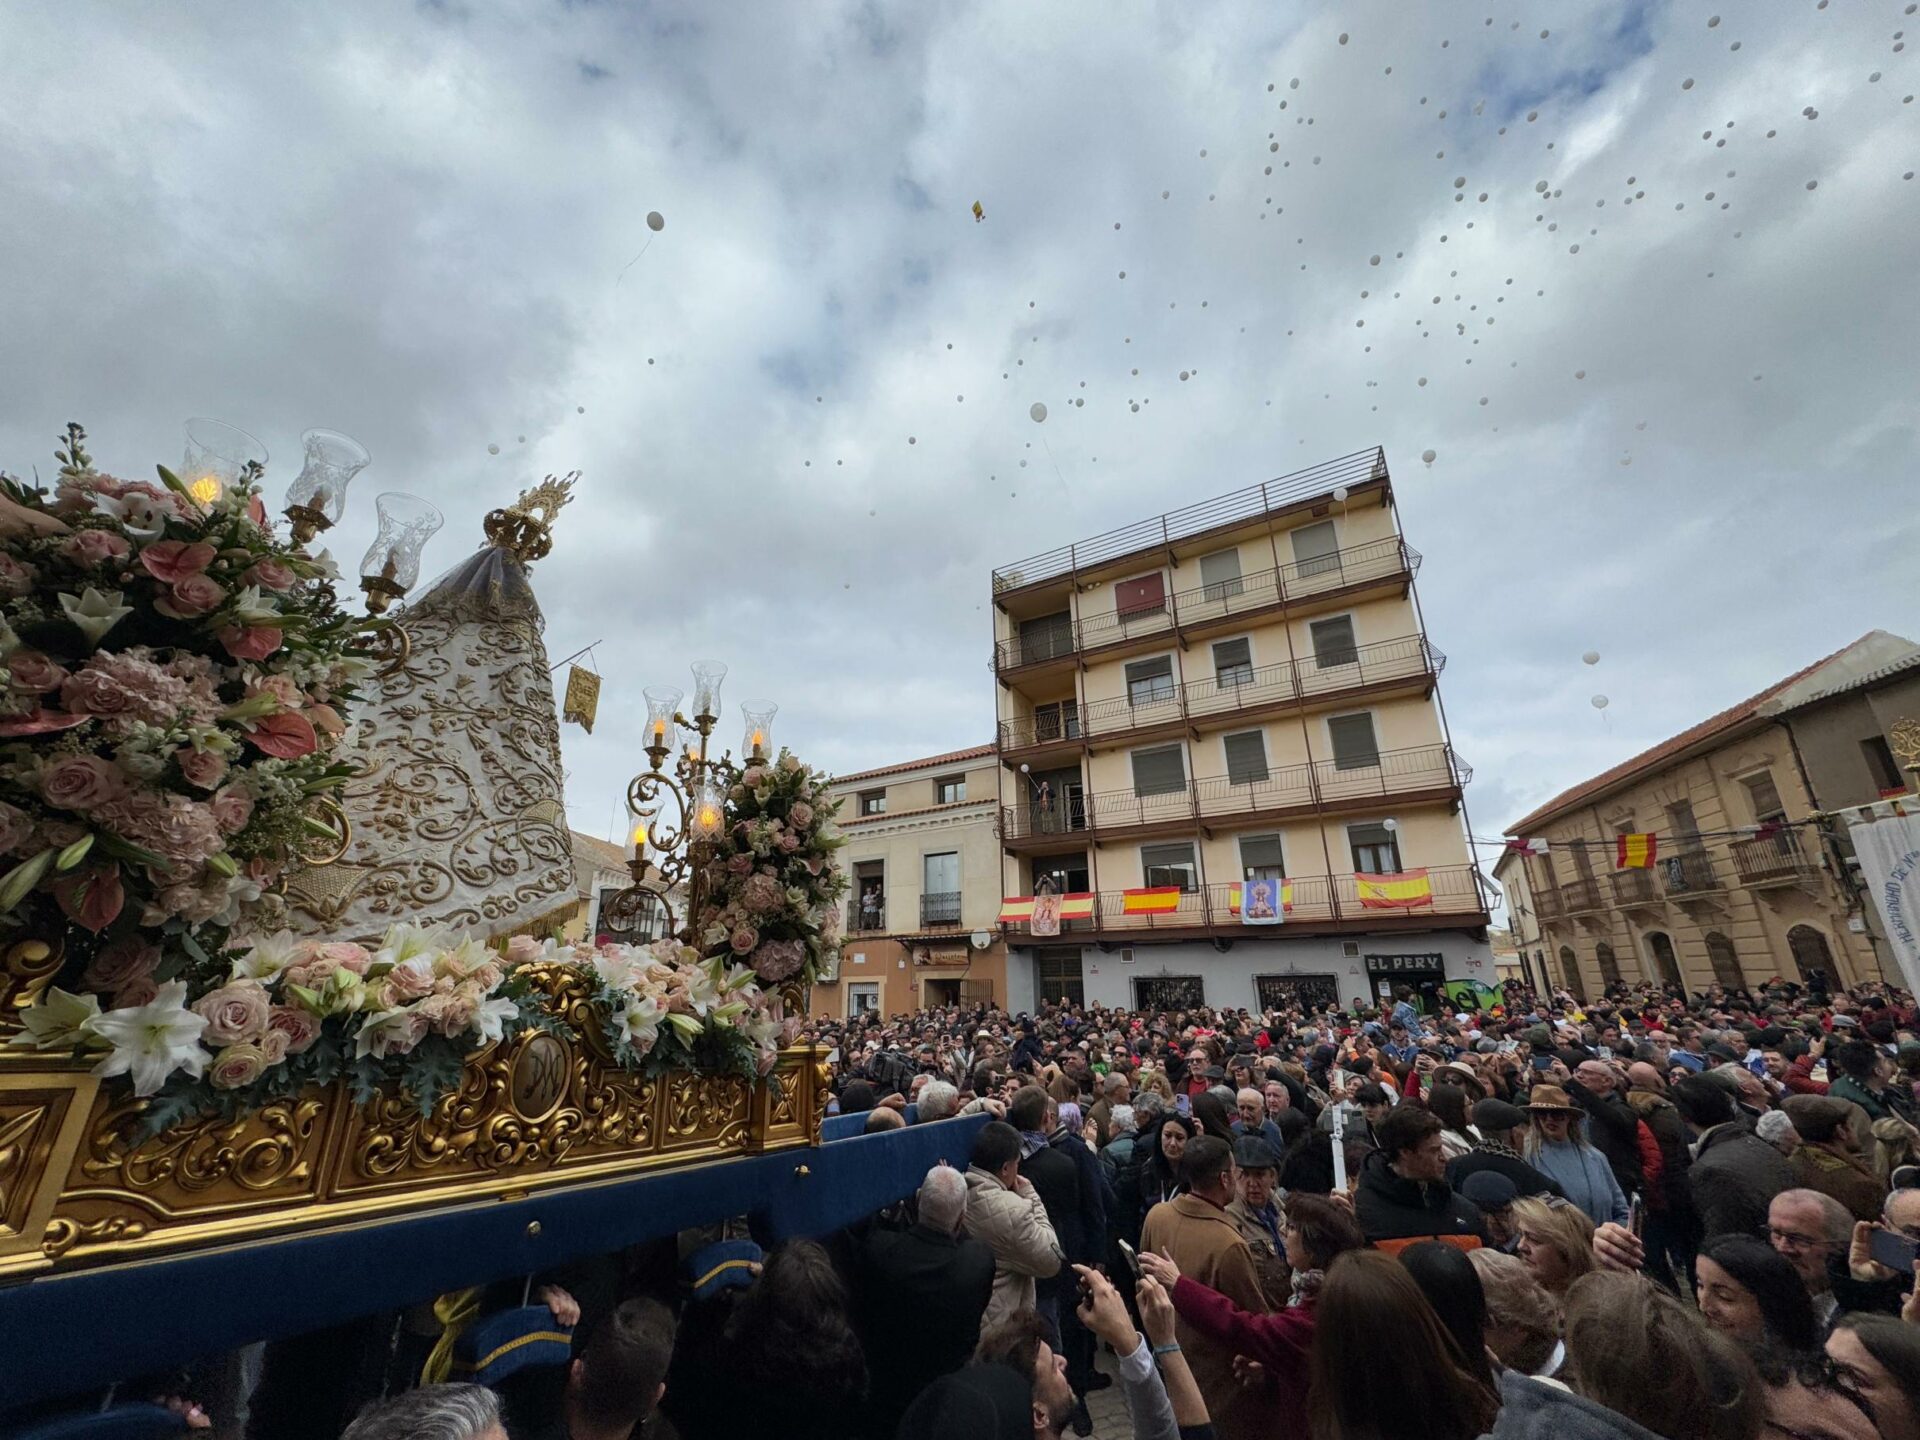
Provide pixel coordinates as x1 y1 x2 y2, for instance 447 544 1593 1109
854 1165 995 1434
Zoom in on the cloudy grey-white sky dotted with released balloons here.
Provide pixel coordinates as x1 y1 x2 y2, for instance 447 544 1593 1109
0 0 1920 852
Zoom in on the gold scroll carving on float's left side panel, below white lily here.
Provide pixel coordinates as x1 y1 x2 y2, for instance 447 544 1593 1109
81 1096 321 1196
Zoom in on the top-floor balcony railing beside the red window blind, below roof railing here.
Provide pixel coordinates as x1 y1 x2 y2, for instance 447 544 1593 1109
993 536 1421 670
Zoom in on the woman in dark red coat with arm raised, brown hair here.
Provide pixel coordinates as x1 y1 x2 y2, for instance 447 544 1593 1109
1140 1192 1365 1436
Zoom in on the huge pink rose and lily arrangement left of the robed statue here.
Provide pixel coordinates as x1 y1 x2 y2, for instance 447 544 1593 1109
0 424 371 975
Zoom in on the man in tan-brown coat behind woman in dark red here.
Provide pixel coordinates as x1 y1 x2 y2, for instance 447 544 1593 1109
1140 1135 1286 1440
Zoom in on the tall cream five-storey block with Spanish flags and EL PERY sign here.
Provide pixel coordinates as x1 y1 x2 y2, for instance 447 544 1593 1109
993 449 1494 1010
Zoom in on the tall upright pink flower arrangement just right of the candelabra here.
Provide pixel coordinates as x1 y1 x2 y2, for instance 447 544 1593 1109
693 751 847 985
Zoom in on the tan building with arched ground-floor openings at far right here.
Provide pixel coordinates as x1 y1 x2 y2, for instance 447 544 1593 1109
1501 630 1920 998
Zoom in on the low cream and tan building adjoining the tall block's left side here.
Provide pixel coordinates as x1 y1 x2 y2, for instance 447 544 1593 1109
812 745 1006 1016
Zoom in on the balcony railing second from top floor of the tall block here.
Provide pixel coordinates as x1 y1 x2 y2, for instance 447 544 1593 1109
1000 636 1446 751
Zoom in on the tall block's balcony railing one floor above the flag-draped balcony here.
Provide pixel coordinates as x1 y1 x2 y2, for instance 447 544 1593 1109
1000 745 1473 841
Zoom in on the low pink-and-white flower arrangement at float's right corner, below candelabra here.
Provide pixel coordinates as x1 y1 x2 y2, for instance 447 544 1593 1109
507 935 801 1079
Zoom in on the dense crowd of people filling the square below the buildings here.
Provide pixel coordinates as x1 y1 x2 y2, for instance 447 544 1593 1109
37 985 1920 1440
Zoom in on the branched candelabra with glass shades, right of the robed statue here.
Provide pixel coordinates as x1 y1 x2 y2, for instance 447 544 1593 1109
607 660 780 948
